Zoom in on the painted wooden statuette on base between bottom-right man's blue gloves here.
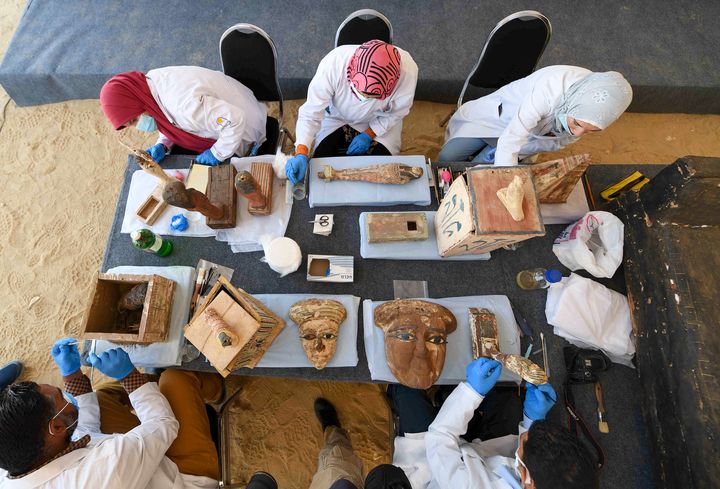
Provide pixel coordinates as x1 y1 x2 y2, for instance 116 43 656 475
469 307 548 385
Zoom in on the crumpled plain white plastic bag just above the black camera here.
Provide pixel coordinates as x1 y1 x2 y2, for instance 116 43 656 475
545 273 635 367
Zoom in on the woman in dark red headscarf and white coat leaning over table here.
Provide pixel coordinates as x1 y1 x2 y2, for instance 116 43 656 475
100 66 267 165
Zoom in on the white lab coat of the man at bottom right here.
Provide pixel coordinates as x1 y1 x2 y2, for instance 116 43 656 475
393 382 532 489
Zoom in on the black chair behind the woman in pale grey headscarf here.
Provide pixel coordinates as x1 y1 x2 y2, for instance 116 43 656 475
457 10 552 108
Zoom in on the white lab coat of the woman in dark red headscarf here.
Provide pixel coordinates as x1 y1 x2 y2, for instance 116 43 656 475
145 66 267 161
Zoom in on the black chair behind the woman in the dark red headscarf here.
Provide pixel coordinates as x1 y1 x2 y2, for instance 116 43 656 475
220 24 294 154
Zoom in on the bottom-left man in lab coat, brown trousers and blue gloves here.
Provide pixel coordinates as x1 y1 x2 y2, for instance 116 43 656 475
0 338 223 489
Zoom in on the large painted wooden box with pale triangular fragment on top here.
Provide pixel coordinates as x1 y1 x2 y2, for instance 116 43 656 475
435 166 545 256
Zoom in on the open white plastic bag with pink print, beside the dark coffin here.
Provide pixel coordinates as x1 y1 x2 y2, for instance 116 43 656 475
553 211 625 278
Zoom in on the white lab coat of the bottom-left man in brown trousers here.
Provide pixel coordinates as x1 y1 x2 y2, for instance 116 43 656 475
0 382 218 489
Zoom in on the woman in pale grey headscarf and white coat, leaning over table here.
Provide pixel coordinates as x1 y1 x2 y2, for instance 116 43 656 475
438 66 632 166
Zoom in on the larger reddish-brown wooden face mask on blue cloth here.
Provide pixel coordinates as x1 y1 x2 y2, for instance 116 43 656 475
375 299 457 389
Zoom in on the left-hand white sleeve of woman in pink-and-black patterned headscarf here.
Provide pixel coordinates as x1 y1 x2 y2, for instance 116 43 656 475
295 53 337 150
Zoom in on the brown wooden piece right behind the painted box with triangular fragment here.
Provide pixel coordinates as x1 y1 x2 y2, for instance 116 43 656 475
530 153 590 204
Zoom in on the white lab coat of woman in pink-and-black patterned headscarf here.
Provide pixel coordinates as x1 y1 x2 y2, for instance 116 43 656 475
295 45 418 155
